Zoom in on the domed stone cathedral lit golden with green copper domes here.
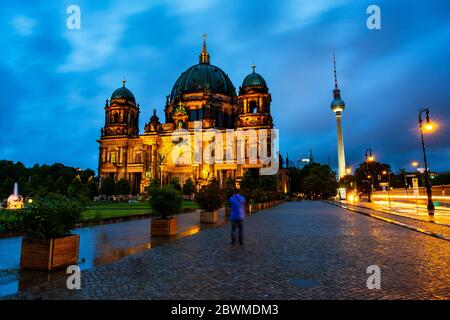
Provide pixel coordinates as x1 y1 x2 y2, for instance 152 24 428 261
97 35 286 194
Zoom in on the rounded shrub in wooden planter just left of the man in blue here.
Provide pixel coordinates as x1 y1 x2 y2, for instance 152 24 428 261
195 181 226 223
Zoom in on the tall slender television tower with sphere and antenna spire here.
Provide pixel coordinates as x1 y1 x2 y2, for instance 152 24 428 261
331 52 345 179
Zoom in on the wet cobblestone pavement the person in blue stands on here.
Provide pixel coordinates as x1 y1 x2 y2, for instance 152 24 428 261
9 201 450 299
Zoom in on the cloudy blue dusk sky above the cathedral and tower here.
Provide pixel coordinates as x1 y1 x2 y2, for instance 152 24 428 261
0 0 450 171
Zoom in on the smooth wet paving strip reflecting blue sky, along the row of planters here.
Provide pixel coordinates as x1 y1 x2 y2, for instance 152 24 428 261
0 210 228 297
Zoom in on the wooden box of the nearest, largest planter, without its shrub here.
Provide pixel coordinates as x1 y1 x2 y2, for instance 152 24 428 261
20 234 80 271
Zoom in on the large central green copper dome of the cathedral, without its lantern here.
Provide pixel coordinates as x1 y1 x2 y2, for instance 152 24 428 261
171 63 236 99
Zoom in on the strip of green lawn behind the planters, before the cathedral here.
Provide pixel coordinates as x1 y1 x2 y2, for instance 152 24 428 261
81 201 198 221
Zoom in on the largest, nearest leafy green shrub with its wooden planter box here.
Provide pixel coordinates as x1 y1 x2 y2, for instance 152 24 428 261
18 194 83 270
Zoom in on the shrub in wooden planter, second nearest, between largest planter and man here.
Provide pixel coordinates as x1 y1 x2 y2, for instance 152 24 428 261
150 185 183 237
